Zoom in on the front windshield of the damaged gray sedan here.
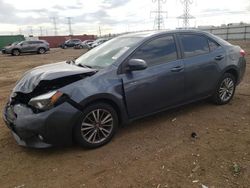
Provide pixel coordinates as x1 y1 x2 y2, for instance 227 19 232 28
75 37 142 68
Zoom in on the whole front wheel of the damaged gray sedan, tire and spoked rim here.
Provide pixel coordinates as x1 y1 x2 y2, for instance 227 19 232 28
74 103 118 148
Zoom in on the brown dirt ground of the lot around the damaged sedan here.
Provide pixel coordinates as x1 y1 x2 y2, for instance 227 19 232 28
0 41 250 188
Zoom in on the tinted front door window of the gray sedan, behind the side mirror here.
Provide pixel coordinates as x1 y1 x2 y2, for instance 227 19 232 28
132 36 177 66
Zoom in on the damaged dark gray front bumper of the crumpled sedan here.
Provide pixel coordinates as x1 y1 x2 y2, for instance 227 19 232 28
3 102 81 148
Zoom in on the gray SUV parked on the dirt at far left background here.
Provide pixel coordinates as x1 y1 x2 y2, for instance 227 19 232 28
2 40 50 56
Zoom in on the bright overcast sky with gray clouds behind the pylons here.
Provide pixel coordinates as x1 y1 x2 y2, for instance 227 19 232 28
0 0 250 35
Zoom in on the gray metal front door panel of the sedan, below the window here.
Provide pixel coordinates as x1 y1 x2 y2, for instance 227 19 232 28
122 60 184 118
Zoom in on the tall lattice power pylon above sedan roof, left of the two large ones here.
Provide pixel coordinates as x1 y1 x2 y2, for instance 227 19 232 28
150 0 167 30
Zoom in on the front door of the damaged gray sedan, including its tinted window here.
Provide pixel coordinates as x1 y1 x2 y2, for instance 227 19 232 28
122 35 184 118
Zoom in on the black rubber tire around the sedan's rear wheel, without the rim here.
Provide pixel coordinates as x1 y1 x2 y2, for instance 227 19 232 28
212 73 236 105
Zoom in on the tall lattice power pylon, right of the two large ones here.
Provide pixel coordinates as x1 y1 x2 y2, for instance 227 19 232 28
178 0 195 29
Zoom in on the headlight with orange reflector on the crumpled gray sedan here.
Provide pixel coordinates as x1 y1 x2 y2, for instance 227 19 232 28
29 91 63 111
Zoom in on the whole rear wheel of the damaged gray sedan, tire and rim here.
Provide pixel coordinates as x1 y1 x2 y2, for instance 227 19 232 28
212 73 236 105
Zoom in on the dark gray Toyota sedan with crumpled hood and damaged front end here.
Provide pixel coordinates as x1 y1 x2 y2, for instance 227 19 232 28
3 30 246 148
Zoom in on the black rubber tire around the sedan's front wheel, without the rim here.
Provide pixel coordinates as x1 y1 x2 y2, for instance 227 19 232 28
73 103 118 149
